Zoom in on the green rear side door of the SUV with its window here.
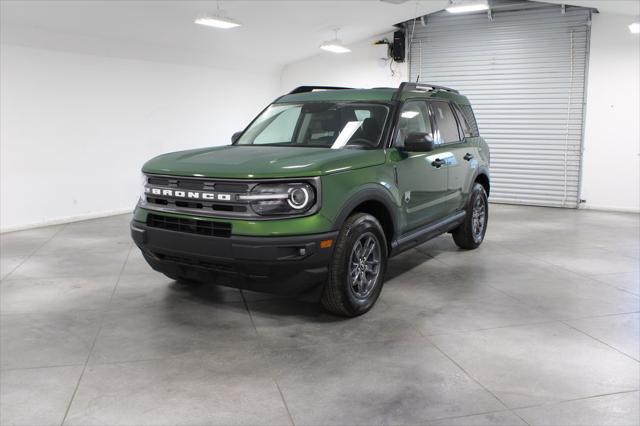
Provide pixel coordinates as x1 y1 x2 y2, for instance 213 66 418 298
429 101 476 213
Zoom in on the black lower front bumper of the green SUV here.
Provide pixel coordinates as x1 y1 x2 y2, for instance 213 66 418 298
131 220 338 295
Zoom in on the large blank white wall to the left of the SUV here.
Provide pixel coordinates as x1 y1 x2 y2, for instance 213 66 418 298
0 44 279 231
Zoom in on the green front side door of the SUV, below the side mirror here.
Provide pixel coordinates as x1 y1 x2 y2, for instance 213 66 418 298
390 100 453 233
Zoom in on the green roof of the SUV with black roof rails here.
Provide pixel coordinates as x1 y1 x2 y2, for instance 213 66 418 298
275 87 469 105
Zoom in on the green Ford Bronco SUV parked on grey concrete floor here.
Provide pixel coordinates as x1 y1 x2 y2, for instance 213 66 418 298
131 83 489 316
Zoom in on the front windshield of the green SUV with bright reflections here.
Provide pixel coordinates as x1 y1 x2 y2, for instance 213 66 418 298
236 102 389 149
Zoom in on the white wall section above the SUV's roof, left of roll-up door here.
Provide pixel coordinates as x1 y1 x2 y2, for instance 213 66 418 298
281 33 407 92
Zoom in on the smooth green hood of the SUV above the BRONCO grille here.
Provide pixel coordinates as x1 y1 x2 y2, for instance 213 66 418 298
142 145 385 179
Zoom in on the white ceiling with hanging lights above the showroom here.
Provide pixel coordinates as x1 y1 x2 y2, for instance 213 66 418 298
0 0 640 72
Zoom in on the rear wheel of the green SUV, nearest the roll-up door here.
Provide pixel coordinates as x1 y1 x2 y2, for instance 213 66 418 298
451 182 489 250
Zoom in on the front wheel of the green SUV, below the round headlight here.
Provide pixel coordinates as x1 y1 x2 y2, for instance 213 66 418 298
320 213 387 317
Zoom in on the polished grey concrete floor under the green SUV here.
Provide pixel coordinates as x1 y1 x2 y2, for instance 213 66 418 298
0 205 640 425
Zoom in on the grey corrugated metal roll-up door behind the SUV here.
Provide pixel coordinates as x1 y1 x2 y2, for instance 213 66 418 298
407 3 591 207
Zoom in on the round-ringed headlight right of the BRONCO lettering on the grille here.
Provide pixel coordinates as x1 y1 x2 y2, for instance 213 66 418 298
238 183 316 216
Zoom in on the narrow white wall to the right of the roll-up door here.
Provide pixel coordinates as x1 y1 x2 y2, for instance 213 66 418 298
582 13 640 212
